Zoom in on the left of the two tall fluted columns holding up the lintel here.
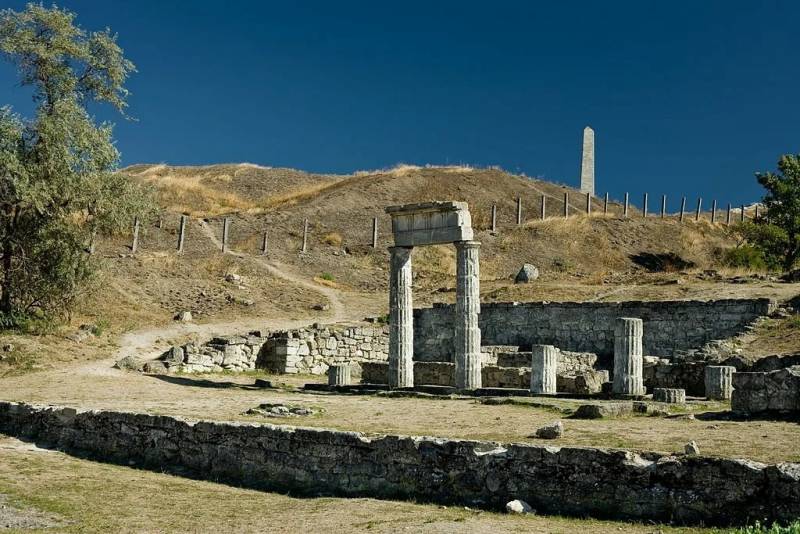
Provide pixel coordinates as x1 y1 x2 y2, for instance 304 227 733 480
389 247 414 388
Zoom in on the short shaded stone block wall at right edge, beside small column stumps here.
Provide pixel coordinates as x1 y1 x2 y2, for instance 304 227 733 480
731 365 800 414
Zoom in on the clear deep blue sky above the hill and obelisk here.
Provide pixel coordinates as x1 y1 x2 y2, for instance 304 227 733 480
0 0 800 209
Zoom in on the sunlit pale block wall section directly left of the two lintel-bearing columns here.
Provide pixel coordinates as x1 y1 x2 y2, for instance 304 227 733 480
256 325 389 376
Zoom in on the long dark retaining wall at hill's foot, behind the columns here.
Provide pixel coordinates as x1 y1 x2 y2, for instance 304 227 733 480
414 299 774 361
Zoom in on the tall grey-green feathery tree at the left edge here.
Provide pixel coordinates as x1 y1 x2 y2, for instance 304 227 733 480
0 4 153 324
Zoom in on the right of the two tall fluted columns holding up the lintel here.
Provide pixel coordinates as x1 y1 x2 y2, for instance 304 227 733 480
454 241 481 389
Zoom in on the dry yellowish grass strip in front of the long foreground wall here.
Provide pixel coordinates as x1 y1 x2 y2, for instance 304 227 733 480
0 438 709 534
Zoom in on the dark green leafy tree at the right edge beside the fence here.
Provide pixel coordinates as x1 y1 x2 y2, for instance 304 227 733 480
743 154 800 271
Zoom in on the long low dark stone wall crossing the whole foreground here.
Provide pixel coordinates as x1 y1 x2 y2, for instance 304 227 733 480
0 402 800 524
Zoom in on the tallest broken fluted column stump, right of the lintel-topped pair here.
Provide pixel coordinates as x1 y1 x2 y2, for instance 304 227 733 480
612 317 644 395
